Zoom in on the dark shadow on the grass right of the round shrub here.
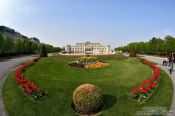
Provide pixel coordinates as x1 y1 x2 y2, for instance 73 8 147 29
103 94 117 110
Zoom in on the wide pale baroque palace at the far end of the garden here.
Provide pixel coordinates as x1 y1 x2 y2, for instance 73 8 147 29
65 42 111 54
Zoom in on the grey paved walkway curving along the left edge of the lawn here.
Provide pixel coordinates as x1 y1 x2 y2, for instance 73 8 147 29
0 56 32 116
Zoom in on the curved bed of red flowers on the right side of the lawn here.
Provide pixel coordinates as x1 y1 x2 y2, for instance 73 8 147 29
130 57 160 104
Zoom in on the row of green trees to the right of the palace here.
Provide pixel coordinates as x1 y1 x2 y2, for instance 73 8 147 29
115 35 175 54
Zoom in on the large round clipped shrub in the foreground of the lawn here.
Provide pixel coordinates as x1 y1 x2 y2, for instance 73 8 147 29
73 84 103 114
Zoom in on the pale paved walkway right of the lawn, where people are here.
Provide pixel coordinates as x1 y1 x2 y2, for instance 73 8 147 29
143 55 175 116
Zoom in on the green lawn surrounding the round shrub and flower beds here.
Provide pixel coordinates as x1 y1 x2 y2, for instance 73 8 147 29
3 56 173 116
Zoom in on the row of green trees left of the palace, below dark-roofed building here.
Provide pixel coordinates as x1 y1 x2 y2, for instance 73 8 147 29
0 33 61 55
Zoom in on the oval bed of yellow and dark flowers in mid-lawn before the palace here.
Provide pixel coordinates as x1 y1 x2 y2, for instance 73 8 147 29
68 57 109 69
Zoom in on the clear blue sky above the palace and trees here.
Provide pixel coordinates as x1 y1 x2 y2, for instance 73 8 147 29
0 0 175 48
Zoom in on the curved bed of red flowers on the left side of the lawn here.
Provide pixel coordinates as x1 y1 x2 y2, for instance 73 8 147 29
15 57 45 101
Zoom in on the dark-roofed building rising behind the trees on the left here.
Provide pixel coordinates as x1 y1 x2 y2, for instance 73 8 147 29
0 26 40 43
